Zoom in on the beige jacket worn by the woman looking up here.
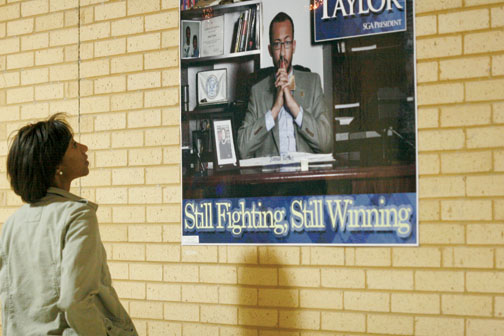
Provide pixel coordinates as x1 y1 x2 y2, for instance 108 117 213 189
0 188 137 336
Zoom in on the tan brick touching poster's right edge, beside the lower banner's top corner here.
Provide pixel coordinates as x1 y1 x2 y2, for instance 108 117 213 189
420 176 465 198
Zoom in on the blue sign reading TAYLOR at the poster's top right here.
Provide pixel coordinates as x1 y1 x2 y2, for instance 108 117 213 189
313 0 406 42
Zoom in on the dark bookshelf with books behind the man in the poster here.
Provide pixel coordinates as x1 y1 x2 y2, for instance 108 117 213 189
180 0 267 171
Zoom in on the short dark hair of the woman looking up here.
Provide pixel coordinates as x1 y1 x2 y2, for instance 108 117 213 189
7 113 73 203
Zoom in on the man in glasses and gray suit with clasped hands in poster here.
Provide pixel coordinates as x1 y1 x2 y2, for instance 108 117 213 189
238 12 333 159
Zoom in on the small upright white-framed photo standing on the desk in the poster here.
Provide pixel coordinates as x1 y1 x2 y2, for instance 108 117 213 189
213 119 236 166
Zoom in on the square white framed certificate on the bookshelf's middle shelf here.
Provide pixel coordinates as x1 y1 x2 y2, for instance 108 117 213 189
197 69 227 105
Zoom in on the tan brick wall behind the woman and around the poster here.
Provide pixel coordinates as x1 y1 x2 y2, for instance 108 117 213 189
0 0 504 336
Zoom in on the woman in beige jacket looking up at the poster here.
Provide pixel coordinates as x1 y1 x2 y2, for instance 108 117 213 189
0 113 137 336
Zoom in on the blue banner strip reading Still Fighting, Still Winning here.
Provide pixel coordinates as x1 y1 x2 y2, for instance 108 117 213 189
182 193 417 245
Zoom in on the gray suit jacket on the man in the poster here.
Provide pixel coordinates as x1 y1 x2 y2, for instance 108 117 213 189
238 70 333 159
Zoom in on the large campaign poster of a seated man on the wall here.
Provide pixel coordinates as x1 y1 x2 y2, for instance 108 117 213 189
180 0 418 246
